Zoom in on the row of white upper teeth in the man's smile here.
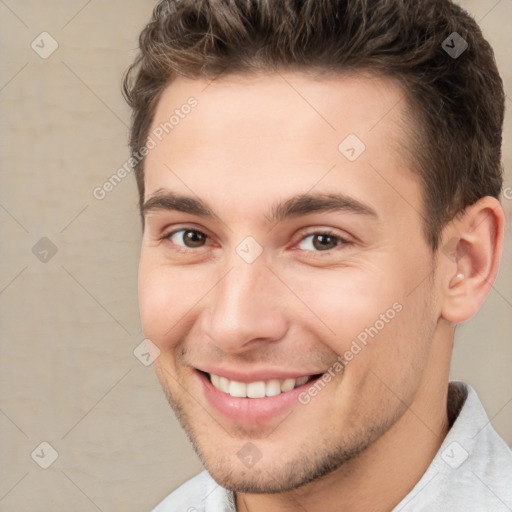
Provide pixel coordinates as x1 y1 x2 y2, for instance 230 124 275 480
210 373 312 398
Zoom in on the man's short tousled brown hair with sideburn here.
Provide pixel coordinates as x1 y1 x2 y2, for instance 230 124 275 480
123 0 505 250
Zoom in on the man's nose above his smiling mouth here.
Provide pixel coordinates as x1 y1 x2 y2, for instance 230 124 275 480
203 255 288 353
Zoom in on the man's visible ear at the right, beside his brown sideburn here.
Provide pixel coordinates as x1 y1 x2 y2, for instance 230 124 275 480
438 196 505 323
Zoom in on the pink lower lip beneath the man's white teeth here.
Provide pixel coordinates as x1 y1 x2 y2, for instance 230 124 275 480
195 371 318 425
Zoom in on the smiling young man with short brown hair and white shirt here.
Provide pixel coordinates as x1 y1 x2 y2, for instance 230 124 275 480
124 0 512 512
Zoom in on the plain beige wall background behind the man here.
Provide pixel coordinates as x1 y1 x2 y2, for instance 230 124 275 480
0 0 512 512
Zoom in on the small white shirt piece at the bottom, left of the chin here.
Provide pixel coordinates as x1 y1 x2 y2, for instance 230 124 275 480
152 471 211 512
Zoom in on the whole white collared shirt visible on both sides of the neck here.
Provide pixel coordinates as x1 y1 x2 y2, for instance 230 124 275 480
152 382 512 512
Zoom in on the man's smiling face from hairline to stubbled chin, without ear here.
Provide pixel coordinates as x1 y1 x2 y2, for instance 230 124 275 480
139 73 439 492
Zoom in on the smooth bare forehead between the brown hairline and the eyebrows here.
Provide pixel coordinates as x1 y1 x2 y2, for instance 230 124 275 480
145 73 418 218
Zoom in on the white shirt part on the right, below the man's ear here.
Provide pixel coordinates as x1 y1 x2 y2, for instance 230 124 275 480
394 383 512 512
